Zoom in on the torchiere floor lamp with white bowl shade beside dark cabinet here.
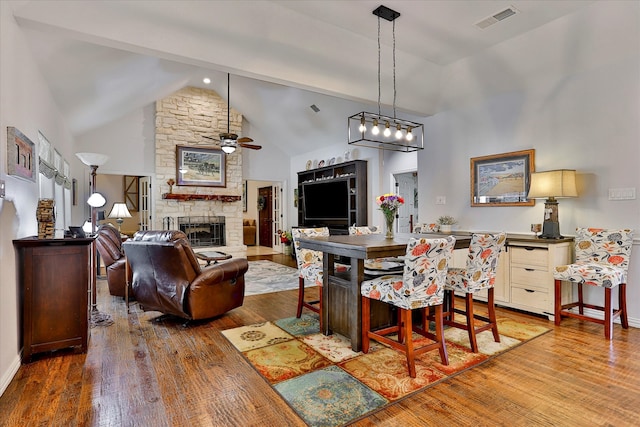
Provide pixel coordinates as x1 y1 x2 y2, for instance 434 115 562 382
76 153 113 326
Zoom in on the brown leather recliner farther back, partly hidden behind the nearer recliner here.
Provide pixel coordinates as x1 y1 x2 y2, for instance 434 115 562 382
96 224 127 297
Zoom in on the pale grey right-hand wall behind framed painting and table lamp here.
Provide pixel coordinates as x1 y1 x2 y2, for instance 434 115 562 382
418 2 640 320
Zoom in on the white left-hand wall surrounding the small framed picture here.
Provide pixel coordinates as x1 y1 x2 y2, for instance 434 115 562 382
0 2 82 394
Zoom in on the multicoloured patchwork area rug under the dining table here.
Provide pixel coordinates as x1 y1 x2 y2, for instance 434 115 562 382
222 315 549 426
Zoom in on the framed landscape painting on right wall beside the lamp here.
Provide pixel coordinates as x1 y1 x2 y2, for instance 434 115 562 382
470 149 535 206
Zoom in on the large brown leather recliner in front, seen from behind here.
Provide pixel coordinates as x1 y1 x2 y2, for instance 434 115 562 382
123 230 249 320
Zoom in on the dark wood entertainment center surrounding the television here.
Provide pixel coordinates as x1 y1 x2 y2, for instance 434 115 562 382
298 160 368 234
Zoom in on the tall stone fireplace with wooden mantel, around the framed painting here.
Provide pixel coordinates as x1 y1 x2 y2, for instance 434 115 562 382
151 87 246 251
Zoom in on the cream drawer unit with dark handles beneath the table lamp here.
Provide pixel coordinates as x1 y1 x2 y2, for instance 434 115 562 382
508 239 572 318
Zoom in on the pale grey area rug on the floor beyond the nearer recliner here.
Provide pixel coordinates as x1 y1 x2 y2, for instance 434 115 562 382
244 260 298 296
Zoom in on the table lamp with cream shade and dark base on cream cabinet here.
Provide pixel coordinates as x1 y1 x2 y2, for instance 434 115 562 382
527 169 578 239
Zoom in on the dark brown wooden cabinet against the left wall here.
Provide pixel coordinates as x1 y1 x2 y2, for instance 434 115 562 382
13 237 93 363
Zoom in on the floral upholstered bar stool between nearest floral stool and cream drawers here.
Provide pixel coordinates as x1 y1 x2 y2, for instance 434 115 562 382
444 233 507 353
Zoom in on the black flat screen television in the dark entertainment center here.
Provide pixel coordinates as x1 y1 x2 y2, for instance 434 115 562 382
302 180 349 225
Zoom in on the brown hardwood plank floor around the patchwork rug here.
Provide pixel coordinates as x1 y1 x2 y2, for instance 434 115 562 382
0 255 640 426
